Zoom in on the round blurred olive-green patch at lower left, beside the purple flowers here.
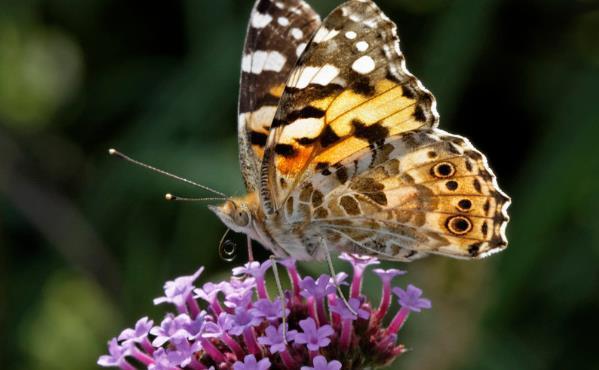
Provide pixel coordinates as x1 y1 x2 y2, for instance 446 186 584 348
17 271 121 370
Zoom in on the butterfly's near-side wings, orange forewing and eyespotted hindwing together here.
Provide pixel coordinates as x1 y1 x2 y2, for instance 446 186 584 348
260 0 510 261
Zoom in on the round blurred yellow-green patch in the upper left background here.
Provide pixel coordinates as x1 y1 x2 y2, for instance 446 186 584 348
0 22 81 130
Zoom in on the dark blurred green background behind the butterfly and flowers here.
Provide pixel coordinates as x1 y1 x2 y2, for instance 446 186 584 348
0 0 599 370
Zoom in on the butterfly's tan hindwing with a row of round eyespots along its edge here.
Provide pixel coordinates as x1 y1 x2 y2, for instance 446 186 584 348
296 129 510 261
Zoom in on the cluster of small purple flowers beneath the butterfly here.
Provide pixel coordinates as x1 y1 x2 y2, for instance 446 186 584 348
98 254 431 370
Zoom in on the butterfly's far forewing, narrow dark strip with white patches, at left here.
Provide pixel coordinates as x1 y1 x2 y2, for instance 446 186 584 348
238 0 320 192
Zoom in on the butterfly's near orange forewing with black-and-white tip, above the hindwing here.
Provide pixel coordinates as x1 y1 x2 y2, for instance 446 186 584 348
260 0 439 214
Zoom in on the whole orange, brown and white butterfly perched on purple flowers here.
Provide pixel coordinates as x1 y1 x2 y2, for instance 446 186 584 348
210 0 510 262
